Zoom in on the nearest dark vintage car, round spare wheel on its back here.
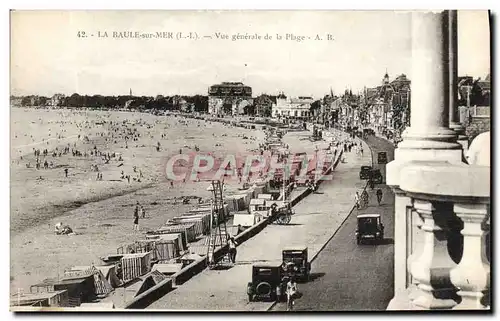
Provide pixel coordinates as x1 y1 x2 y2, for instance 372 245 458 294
247 265 286 302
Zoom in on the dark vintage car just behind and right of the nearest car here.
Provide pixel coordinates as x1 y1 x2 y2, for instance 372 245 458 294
281 246 311 282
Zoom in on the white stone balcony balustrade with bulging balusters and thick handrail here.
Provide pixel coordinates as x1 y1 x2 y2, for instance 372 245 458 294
396 162 490 310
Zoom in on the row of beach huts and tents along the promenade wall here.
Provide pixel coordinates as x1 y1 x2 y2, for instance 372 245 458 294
11 118 300 309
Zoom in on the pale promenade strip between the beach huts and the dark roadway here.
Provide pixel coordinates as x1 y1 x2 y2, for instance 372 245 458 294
147 133 371 311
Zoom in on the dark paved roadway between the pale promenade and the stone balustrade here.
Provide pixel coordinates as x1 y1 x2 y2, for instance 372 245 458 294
273 137 394 311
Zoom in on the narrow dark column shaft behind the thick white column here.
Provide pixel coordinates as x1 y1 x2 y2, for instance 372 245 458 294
446 10 469 151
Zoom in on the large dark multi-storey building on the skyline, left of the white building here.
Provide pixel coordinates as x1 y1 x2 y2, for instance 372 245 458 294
208 82 253 116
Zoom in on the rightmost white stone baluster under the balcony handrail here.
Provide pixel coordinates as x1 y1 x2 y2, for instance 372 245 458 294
450 203 490 309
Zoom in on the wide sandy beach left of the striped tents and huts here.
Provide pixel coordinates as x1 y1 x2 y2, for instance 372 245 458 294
10 108 264 292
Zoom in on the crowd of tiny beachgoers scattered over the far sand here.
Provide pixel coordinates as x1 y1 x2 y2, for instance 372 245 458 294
13 111 266 234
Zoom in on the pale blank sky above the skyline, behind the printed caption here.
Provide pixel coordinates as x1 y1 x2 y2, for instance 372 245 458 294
11 11 490 98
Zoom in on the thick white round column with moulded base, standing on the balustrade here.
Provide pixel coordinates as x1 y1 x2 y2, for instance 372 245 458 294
396 12 462 162
